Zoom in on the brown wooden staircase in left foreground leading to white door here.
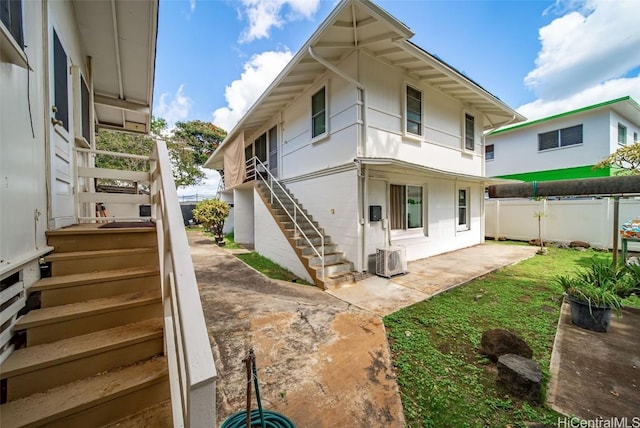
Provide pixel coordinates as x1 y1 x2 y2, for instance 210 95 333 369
0 224 171 428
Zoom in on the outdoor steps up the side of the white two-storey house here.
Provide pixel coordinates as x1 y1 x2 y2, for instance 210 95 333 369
256 181 363 290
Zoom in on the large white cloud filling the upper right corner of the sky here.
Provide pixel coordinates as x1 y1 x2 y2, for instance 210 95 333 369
517 0 640 119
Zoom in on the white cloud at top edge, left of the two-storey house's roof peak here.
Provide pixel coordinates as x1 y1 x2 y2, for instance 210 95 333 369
240 0 320 43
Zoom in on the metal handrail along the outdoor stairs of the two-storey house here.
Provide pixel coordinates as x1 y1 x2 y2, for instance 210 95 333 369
246 156 325 279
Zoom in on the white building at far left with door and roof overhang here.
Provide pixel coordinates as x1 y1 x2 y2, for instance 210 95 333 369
0 0 158 358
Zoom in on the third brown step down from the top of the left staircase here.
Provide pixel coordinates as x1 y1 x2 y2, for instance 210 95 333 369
30 266 160 308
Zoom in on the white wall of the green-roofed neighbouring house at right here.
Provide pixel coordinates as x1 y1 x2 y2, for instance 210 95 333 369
486 110 618 177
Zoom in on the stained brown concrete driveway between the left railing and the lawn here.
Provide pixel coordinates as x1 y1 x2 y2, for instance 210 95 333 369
187 232 404 428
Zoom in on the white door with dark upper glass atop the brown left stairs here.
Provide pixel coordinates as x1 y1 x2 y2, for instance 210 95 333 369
49 27 74 228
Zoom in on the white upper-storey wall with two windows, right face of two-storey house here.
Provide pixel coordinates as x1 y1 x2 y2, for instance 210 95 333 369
360 55 484 175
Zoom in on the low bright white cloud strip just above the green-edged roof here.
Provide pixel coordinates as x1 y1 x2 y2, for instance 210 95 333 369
517 75 640 120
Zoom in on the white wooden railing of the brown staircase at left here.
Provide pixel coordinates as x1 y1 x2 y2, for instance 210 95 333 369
75 141 217 427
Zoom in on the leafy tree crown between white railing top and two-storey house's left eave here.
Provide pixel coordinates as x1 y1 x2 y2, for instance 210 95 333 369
173 120 227 165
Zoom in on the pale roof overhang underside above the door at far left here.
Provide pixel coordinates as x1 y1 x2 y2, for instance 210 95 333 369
73 0 158 133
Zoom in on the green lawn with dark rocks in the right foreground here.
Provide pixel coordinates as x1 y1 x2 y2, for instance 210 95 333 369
384 248 640 428
